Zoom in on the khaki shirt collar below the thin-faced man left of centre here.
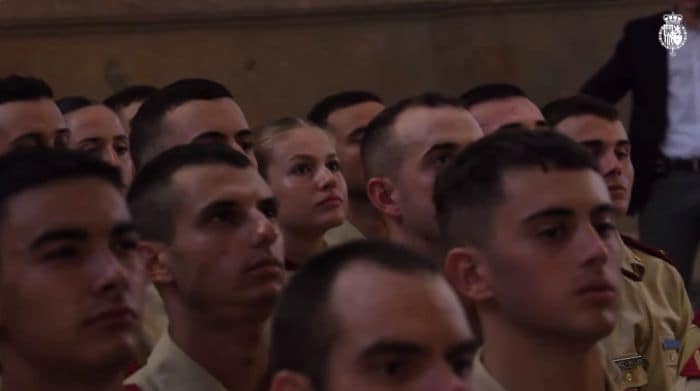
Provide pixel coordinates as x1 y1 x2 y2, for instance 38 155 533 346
124 332 227 391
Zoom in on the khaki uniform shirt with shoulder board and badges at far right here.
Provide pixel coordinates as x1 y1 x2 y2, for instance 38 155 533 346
602 236 692 391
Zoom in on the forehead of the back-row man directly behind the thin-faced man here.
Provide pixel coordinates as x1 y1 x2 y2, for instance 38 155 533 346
164 98 248 143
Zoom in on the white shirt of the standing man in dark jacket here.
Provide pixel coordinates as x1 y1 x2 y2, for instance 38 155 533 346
650 26 700 159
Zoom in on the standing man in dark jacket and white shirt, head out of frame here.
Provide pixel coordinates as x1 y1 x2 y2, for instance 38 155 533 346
582 0 700 294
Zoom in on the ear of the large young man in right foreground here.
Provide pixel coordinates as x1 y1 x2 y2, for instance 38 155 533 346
444 246 493 303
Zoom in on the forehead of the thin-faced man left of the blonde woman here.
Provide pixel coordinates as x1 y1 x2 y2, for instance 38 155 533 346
172 164 272 208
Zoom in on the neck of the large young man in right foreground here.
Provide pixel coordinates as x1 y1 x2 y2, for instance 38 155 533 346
482 321 606 391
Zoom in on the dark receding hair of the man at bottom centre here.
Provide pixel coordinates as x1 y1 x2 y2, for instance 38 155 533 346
269 241 440 390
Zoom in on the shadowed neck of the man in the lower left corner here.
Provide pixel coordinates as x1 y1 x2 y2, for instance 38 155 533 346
1 351 128 391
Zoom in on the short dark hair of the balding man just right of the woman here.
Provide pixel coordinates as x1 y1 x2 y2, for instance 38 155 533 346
361 92 464 178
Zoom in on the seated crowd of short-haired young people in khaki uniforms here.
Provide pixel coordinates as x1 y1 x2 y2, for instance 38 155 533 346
0 76 700 391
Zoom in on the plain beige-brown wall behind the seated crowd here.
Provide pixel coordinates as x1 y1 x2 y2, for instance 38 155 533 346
0 0 668 124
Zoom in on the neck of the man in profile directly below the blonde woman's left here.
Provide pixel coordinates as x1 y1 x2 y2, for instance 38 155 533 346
168 307 267 391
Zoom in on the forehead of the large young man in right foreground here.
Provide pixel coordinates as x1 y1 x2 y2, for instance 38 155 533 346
500 167 610 220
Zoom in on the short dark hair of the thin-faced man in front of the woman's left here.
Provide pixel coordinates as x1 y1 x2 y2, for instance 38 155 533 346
127 144 252 243
